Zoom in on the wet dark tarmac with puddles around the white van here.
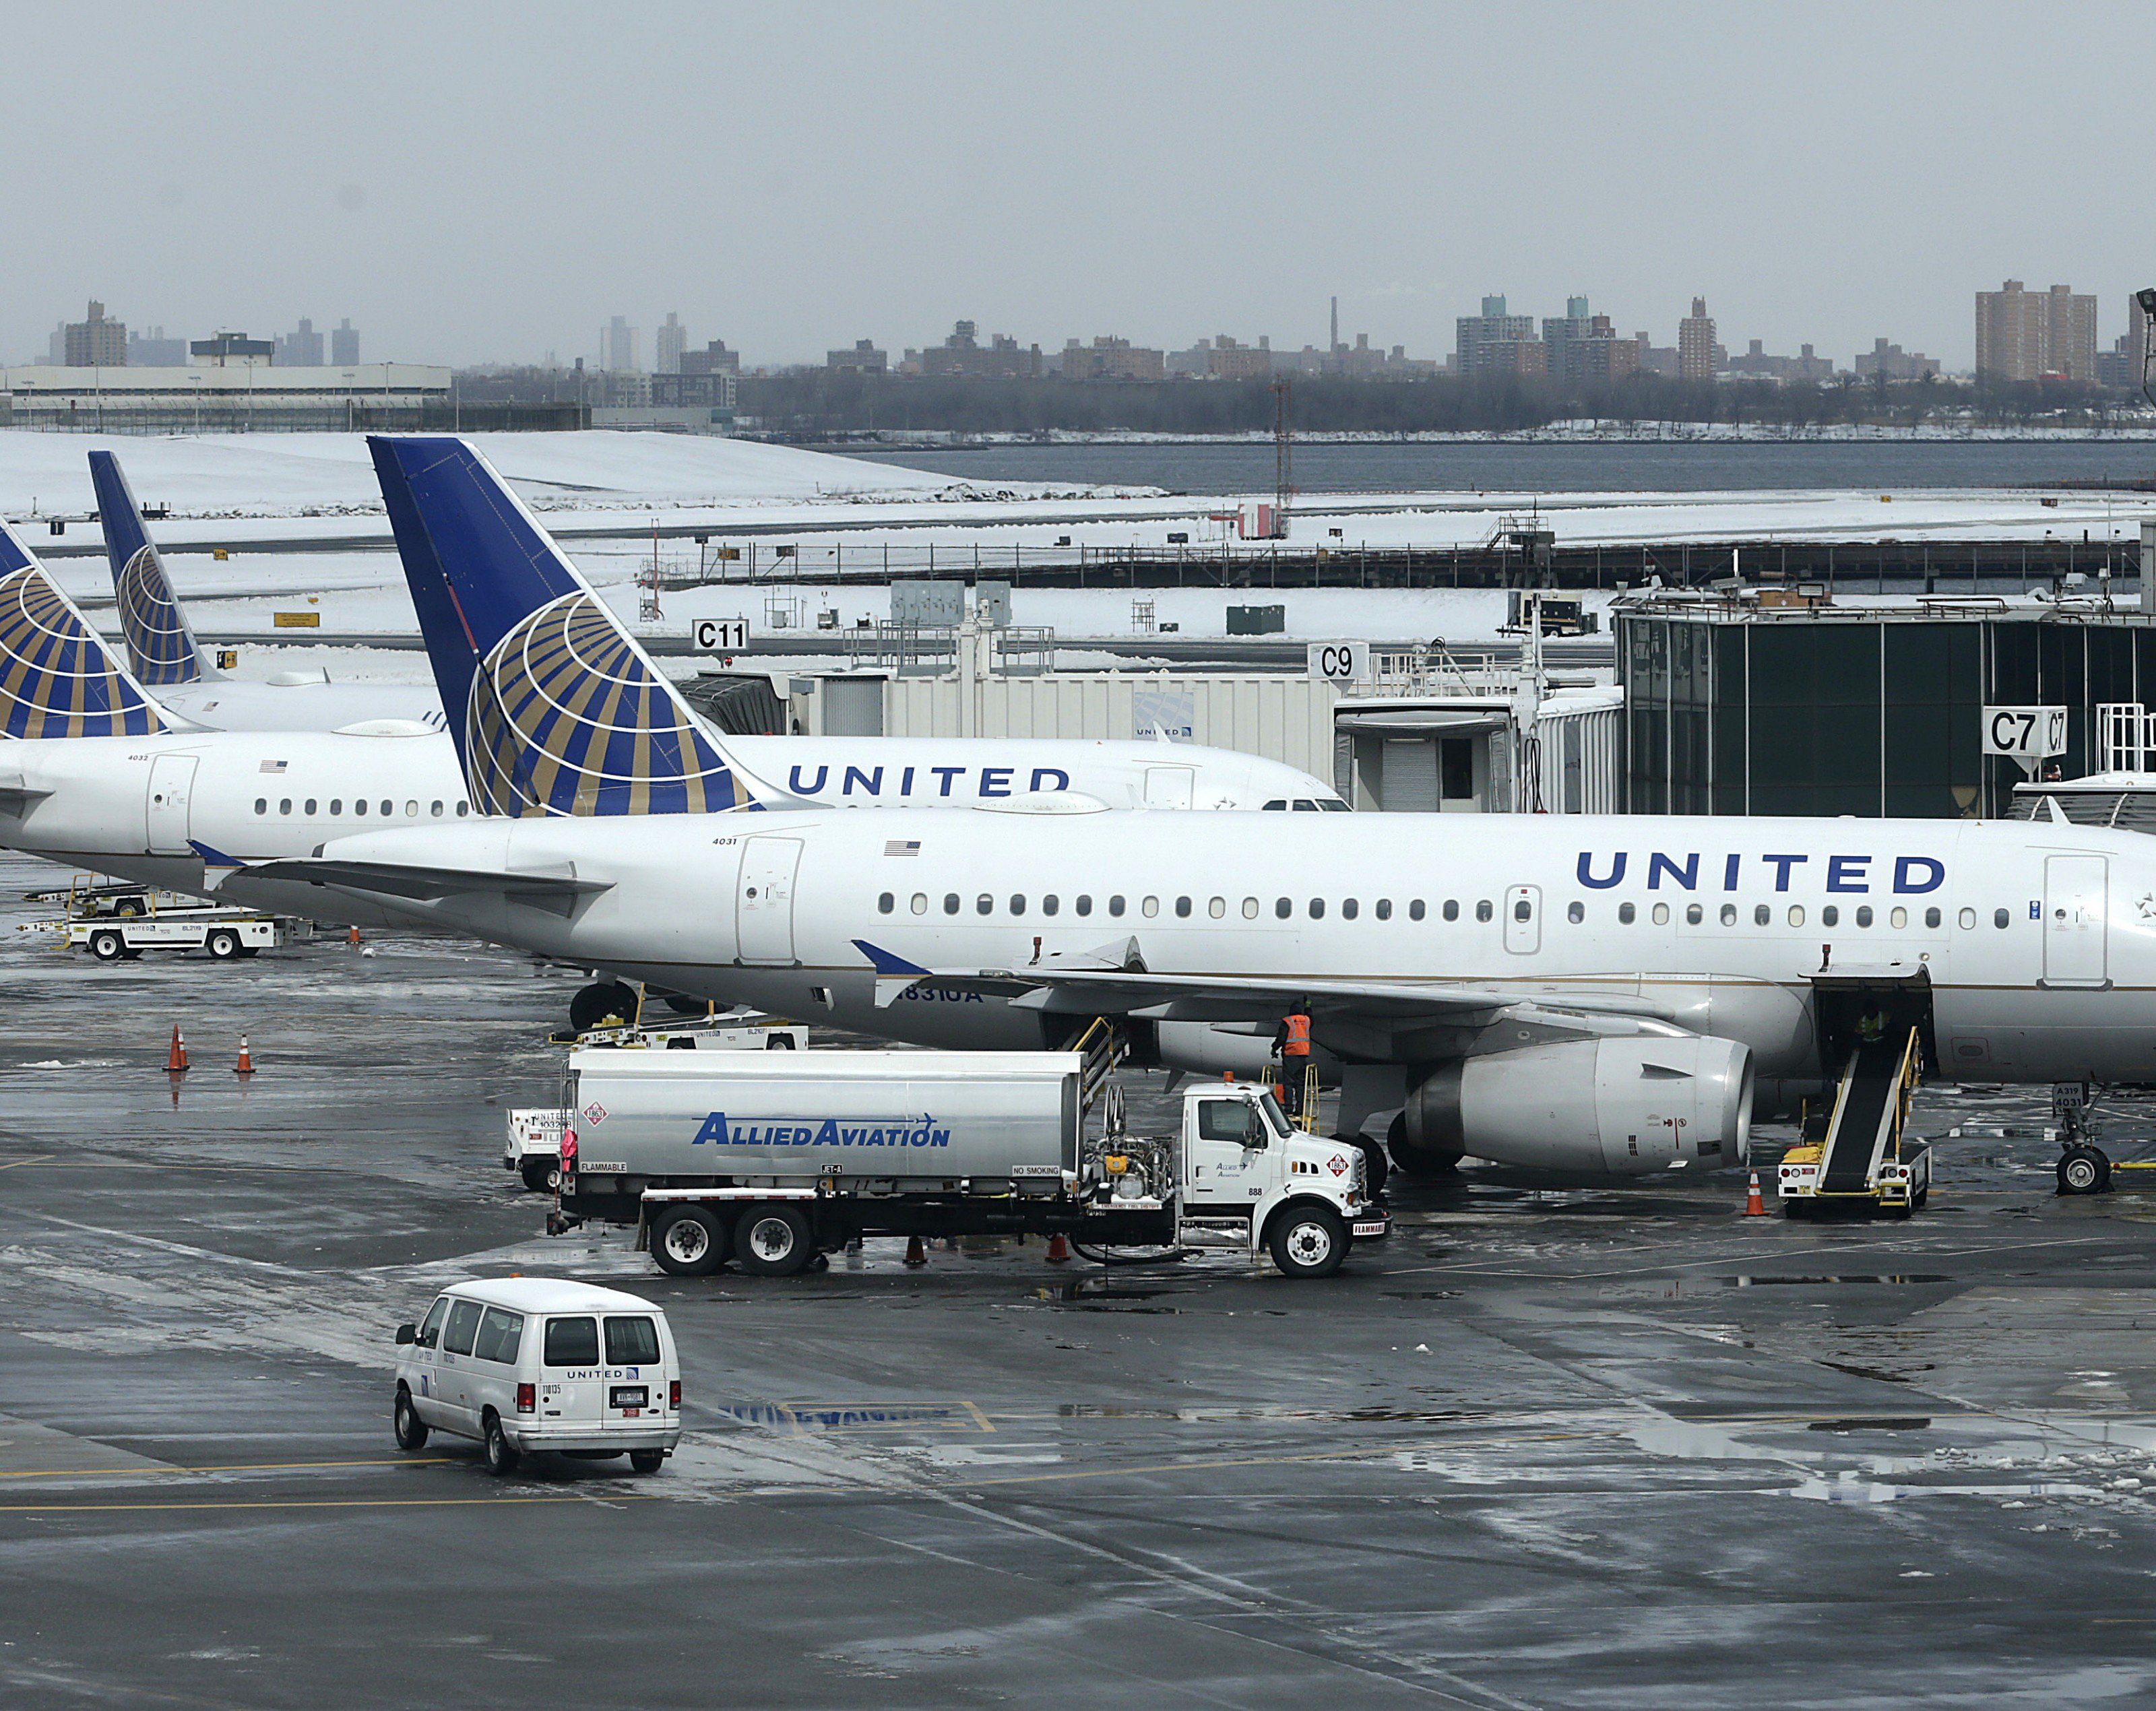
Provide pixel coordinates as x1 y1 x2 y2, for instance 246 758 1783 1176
0 862 2156 1707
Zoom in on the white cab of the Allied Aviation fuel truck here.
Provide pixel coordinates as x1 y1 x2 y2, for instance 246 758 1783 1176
1179 1082 1391 1278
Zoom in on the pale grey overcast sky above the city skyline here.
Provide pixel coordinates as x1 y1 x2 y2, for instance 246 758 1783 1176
0 0 2156 366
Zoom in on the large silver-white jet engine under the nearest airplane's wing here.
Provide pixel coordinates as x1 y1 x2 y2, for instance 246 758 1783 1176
1393 1035 1753 1177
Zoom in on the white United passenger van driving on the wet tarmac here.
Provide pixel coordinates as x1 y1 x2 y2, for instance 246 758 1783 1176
395 1278 681 1474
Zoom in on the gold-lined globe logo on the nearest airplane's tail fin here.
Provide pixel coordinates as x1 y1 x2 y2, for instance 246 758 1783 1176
466 591 746 816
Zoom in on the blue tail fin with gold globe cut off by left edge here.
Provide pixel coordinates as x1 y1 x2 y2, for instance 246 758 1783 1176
0 521 172 737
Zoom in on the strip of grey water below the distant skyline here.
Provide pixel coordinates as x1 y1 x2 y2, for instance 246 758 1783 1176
834 440 2156 494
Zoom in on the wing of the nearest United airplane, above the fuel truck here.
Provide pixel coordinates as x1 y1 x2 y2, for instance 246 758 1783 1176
854 940 1667 1032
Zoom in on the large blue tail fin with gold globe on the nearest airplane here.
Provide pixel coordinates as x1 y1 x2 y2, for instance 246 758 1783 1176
367 435 755 814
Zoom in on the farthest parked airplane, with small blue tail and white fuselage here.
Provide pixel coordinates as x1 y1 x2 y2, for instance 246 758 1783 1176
90 451 444 730
